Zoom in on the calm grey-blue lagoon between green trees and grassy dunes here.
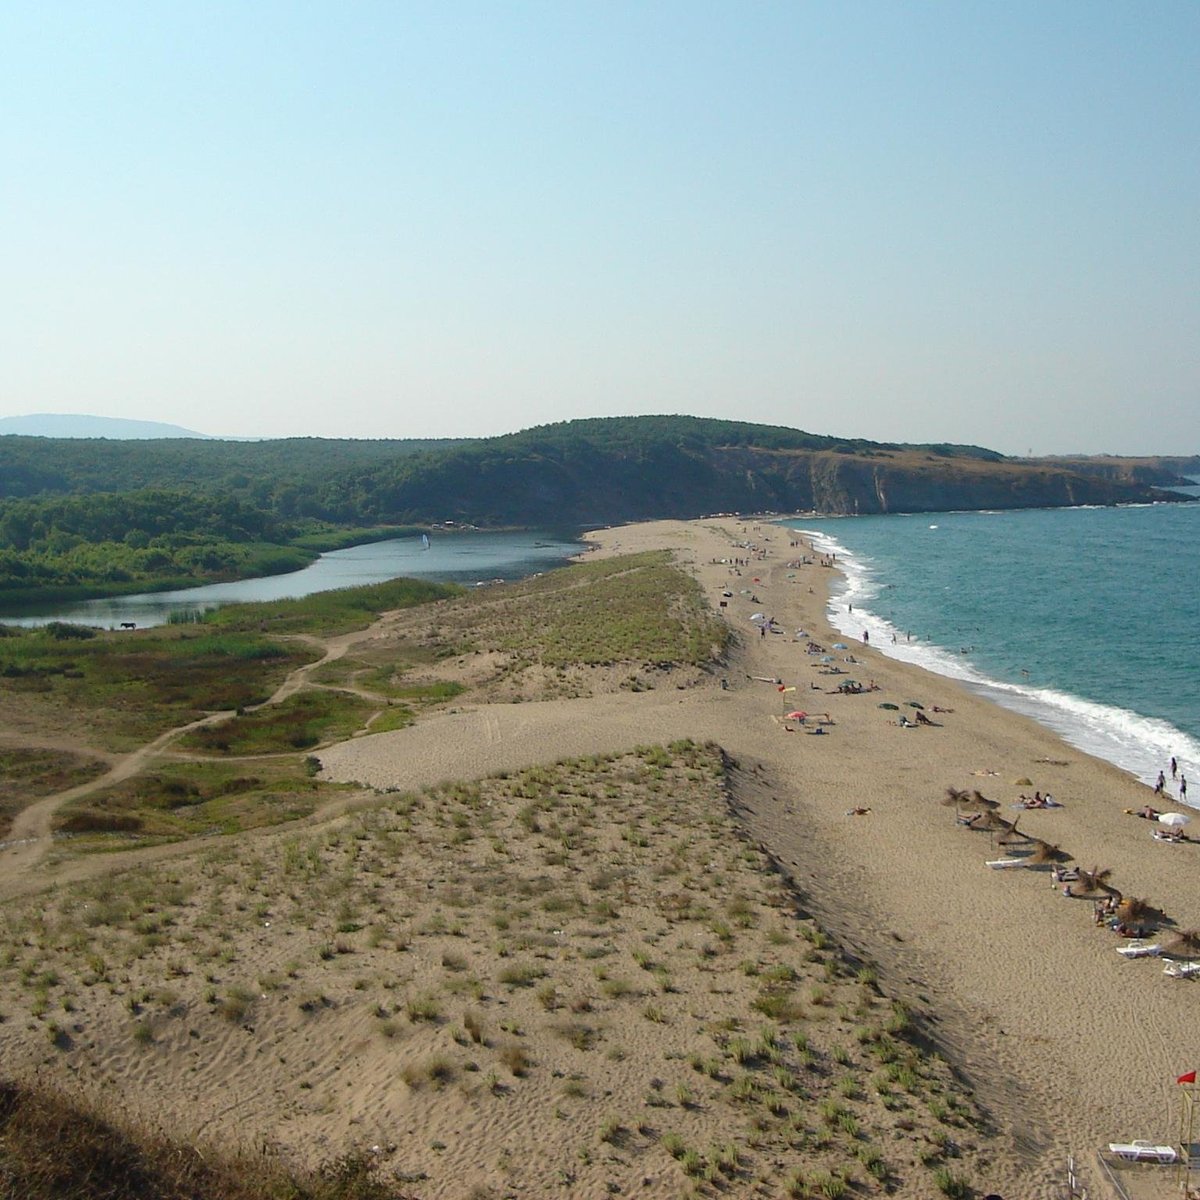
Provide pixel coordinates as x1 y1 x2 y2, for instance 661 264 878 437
0 529 582 628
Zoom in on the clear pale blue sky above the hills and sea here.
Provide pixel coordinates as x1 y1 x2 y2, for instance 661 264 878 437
0 0 1200 454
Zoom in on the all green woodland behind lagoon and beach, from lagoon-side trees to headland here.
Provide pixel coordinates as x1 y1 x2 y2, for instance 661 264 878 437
0 416 1180 602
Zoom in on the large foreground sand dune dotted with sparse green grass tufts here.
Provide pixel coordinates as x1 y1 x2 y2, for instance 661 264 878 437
0 742 985 1195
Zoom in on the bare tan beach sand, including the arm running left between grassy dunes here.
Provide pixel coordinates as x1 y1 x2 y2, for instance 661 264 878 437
323 522 1200 1194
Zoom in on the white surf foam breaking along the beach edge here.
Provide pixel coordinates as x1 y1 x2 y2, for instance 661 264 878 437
800 529 1200 806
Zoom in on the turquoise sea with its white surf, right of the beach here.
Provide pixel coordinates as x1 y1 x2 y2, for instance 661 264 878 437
780 486 1200 806
